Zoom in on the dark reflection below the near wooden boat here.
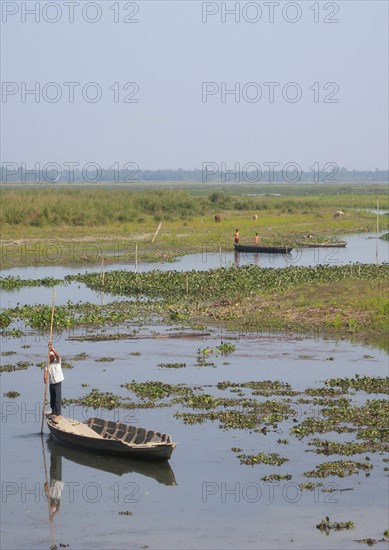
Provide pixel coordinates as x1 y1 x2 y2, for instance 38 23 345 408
47 437 177 485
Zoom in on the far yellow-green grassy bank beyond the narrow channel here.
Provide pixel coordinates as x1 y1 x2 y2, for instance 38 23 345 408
0 186 389 268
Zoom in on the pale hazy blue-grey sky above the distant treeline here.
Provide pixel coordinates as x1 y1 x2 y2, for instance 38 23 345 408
1 0 389 170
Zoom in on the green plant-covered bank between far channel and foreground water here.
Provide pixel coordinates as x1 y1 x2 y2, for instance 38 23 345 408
1 264 389 349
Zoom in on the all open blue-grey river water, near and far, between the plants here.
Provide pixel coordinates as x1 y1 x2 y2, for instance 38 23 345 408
0 231 388 550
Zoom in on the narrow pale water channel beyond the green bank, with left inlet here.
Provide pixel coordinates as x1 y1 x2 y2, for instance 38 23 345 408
0 233 389 308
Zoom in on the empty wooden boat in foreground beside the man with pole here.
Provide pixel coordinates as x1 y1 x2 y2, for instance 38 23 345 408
47 417 177 460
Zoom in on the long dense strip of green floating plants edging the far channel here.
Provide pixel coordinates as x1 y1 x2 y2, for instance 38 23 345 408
69 264 389 299
